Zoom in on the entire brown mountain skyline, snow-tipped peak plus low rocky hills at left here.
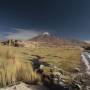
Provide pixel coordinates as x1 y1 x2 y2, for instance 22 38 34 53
1 32 90 48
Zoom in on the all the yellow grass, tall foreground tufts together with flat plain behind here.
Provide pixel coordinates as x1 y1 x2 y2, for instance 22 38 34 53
0 45 80 87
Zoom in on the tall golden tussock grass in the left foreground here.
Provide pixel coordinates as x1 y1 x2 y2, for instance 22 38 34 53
0 46 40 87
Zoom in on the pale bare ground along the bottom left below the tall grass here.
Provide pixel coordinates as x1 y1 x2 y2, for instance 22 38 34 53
0 83 48 90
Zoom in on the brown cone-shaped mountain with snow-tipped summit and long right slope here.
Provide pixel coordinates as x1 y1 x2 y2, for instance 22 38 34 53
28 32 89 47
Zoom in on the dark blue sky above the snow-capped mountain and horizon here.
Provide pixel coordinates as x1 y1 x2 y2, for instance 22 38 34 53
0 0 90 40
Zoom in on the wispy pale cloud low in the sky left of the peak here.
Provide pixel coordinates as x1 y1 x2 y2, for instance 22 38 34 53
5 28 40 40
